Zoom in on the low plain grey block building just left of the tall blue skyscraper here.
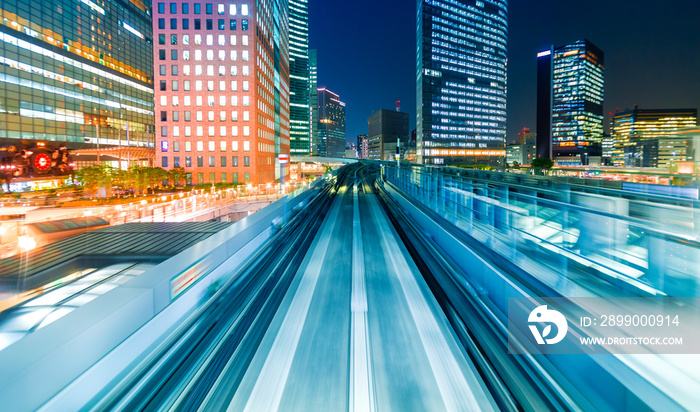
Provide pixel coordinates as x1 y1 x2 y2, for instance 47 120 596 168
367 109 411 160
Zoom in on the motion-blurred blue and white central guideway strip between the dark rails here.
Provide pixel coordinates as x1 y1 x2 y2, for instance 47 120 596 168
228 165 495 411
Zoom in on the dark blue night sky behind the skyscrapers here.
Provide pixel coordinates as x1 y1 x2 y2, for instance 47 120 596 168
309 0 700 142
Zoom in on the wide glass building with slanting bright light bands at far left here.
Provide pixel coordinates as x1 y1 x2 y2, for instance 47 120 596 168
0 0 154 149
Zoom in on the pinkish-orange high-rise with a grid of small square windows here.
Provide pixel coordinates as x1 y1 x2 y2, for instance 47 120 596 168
153 0 290 185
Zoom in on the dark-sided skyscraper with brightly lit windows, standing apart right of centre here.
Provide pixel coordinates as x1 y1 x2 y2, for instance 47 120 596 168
537 39 604 158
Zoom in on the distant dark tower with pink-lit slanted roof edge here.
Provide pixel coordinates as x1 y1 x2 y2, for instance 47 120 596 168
318 88 345 158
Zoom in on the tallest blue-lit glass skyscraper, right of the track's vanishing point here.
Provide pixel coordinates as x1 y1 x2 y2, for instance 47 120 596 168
416 0 508 164
